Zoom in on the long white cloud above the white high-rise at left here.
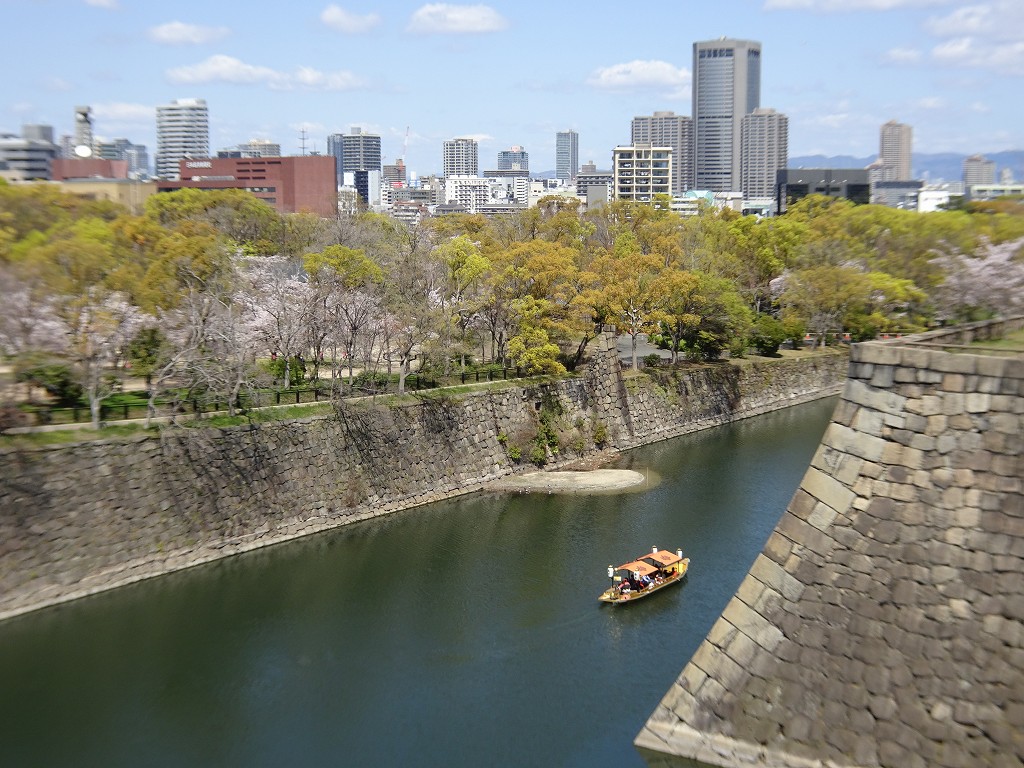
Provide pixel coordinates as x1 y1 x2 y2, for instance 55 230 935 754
167 54 366 91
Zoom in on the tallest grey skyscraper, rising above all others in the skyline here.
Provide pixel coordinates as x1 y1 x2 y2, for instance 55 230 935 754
692 37 761 191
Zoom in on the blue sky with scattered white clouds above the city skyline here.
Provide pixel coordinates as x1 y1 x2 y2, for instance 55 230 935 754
0 0 1024 176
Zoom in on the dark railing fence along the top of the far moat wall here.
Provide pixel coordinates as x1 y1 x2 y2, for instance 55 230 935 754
14 367 525 426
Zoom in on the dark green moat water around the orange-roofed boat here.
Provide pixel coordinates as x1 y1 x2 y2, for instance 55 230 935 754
0 398 836 768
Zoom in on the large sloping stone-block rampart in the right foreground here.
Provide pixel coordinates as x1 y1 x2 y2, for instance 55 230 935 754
637 325 1024 768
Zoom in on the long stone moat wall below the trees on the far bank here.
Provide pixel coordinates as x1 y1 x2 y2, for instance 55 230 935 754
0 338 847 617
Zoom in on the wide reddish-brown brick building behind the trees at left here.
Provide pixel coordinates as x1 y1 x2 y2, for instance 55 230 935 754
157 155 338 218
